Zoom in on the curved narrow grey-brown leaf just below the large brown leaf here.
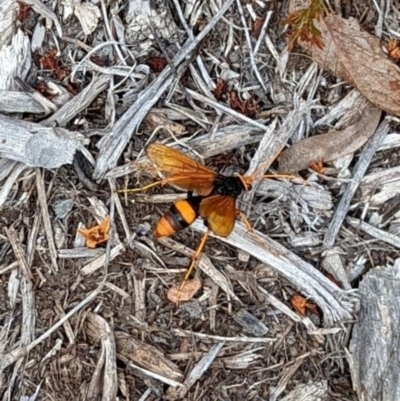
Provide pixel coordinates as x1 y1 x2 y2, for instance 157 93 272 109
278 96 382 174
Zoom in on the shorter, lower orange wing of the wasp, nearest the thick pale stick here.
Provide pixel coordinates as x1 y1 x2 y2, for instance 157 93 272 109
200 195 236 237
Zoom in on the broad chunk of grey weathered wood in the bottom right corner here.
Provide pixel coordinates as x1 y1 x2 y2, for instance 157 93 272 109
348 259 400 401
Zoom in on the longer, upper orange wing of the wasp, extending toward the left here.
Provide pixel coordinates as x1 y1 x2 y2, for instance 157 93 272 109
146 143 217 196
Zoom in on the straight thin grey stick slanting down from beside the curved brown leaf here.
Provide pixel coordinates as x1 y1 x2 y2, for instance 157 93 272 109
324 120 389 248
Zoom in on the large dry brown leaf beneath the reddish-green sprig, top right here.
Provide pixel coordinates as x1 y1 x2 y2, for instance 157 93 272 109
290 0 400 116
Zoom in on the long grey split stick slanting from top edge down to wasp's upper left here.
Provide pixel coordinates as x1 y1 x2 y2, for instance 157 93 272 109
93 0 233 179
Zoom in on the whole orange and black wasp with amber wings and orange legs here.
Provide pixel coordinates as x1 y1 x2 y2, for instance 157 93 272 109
118 143 285 288
